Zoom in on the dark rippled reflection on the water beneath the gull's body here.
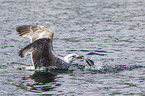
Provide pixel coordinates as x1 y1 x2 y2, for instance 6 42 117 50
16 70 72 93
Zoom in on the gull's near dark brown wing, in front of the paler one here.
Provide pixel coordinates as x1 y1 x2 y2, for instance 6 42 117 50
19 38 54 69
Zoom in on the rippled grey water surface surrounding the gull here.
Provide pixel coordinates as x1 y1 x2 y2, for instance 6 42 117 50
0 0 145 96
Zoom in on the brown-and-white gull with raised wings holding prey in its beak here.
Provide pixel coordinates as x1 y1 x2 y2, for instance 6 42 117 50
16 25 94 71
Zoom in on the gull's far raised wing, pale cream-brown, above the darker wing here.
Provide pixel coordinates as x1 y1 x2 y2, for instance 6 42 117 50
16 25 53 42
